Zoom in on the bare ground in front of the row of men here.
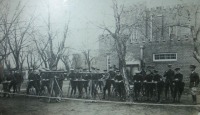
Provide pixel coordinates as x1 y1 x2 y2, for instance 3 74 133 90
0 81 200 115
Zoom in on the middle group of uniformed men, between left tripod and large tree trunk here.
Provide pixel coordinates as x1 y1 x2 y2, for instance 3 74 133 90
68 69 124 99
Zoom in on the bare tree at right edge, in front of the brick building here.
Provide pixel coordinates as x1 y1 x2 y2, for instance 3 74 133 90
170 3 200 63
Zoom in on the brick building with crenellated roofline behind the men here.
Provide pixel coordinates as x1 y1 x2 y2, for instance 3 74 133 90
98 5 200 80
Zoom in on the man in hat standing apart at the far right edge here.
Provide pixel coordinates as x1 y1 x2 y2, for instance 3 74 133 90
190 65 199 104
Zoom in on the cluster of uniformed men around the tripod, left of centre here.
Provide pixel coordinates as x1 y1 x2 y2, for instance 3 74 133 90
26 71 65 96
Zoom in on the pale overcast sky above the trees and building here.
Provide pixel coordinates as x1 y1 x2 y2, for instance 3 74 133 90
11 0 198 53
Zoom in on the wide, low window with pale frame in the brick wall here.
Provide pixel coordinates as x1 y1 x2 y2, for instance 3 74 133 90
153 53 177 61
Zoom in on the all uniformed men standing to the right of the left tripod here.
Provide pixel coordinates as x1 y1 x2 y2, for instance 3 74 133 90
68 64 199 104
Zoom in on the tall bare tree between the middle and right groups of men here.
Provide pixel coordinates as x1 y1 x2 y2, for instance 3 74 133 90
100 0 133 95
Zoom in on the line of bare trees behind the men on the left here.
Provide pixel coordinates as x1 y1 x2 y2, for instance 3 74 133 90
0 0 69 71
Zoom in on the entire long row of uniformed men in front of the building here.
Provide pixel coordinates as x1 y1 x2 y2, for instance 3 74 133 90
2 64 199 104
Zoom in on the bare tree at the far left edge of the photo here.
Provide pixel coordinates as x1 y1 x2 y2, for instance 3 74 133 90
0 0 24 68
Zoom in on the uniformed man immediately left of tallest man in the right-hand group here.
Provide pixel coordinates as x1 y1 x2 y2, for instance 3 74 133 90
153 70 164 102
